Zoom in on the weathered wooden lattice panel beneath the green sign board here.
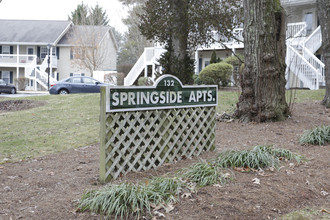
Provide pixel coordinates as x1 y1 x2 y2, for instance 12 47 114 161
101 107 216 181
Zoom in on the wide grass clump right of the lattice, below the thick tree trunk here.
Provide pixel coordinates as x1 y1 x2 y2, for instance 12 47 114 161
217 146 301 169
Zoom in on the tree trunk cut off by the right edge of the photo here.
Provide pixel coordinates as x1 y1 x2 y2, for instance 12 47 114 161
316 0 330 108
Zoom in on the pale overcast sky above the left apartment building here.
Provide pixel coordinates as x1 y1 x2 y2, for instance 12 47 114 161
0 0 127 33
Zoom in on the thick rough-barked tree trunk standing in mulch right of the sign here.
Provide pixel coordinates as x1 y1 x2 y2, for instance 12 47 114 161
236 0 289 122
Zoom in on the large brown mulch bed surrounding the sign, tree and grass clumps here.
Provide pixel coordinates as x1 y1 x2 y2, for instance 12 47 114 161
0 102 330 220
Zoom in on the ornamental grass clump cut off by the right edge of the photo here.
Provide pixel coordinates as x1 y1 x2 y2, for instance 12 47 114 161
299 125 330 145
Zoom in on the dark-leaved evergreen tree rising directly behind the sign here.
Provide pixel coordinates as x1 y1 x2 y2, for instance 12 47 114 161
140 0 240 84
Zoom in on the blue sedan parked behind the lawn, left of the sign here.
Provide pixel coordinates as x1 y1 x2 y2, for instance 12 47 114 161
49 76 110 94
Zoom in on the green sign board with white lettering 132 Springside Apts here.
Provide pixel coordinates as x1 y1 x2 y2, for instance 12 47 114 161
106 75 218 112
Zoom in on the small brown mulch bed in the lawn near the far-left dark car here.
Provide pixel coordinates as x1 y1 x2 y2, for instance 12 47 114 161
0 100 47 112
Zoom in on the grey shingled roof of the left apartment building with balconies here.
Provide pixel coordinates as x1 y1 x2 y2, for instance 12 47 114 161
0 19 72 45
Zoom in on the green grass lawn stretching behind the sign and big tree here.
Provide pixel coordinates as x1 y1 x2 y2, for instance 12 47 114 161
0 90 325 163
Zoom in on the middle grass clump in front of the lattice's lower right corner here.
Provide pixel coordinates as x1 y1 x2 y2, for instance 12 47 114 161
182 162 228 186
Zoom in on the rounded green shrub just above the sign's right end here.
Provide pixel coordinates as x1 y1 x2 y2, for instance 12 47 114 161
199 62 233 87
